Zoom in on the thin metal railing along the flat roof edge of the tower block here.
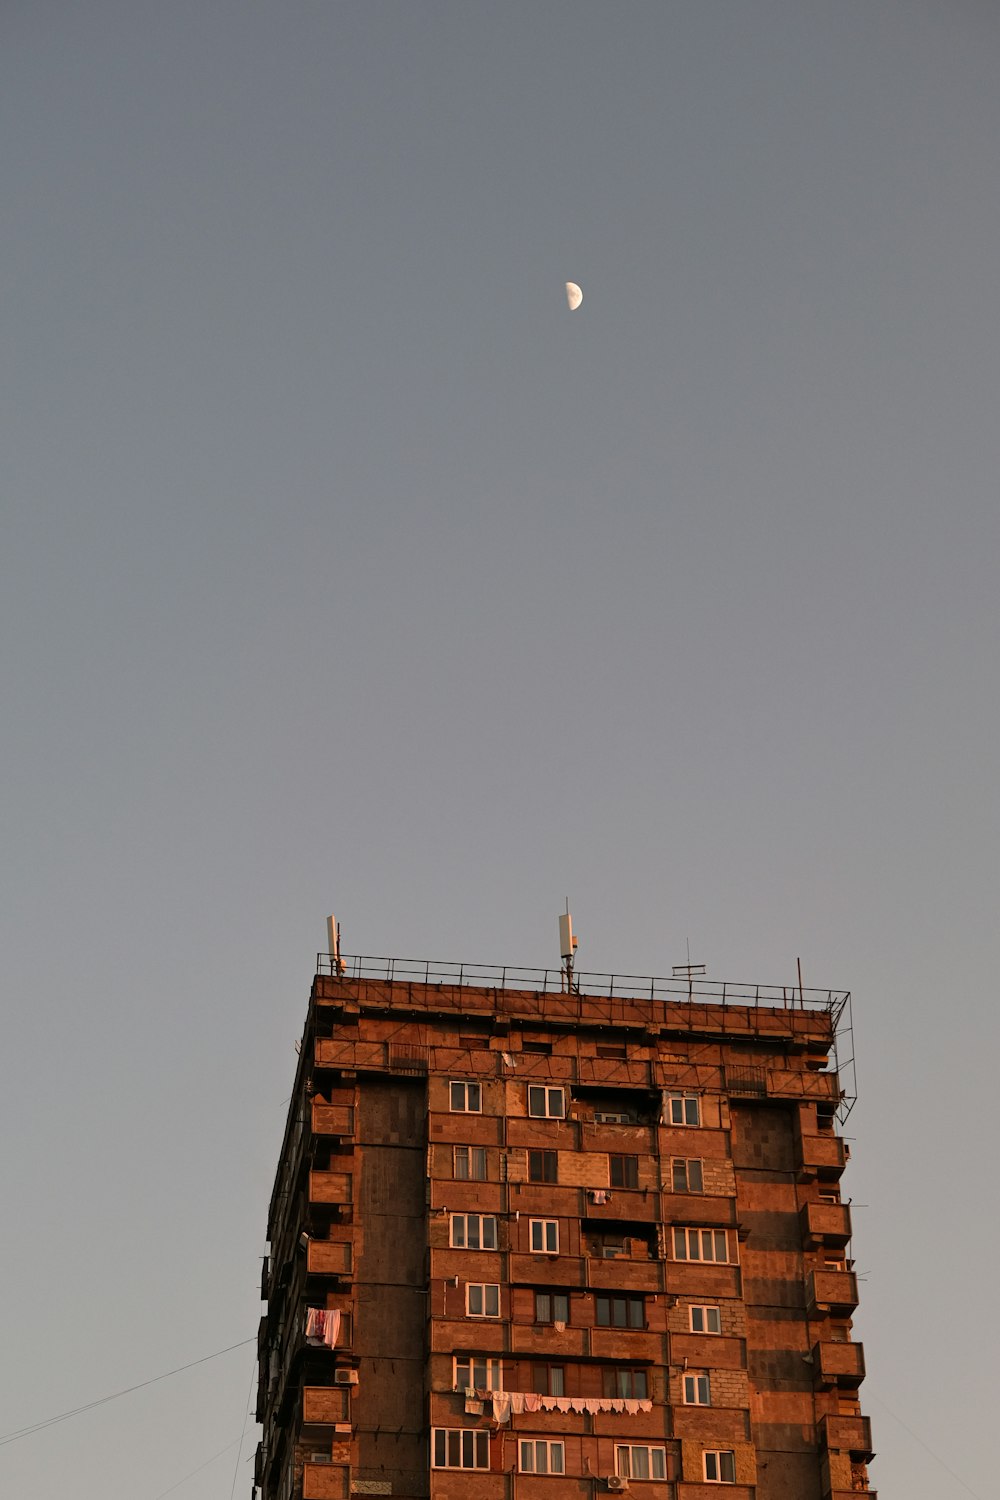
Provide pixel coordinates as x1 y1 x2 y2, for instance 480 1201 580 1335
316 953 850 1020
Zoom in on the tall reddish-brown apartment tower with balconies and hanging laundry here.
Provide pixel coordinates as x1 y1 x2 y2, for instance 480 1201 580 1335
255 956 873 1500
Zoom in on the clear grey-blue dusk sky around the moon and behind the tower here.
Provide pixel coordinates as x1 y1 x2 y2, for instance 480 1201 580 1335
0 0 1000 1500
